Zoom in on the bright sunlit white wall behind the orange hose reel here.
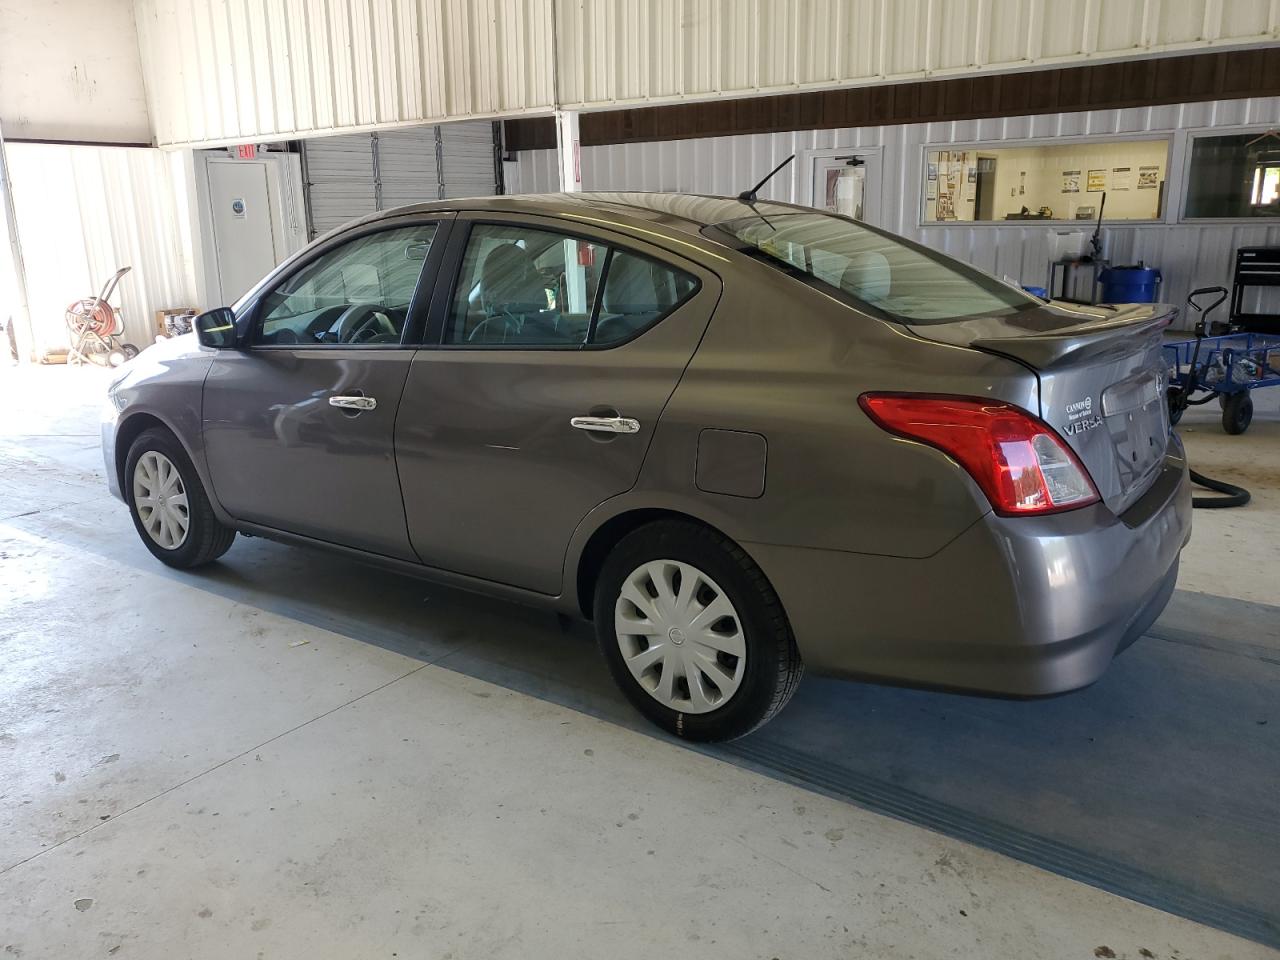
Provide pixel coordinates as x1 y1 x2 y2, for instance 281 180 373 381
6 143 195 355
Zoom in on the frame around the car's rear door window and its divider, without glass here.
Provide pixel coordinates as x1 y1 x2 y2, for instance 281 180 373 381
426 211 703 353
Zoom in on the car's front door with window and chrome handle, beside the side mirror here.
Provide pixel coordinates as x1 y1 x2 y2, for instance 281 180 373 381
204 219 444 559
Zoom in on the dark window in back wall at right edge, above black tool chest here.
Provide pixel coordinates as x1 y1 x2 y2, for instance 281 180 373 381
1187 131 1280 219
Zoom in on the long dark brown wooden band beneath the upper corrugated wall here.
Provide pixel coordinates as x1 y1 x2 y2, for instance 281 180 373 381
504 45 1280 150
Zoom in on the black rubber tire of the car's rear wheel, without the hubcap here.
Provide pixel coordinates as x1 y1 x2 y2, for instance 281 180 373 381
594 520 804 742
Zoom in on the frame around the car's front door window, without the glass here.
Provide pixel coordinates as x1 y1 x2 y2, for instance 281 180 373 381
237 211 456 351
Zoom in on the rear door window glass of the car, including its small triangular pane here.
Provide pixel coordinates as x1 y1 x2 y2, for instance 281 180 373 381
444 224 698 349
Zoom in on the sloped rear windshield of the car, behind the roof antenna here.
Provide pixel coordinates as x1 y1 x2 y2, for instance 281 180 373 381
709 212 1042 324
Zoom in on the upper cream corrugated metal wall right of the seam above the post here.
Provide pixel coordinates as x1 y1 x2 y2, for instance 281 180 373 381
556 0 1280 106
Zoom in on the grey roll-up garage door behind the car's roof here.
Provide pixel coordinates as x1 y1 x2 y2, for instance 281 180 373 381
302 120 500 237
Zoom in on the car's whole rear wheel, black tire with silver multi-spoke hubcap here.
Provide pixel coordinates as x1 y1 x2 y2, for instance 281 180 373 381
595 521 804 741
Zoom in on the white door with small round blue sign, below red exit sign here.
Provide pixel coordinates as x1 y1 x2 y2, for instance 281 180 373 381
209 160 279 303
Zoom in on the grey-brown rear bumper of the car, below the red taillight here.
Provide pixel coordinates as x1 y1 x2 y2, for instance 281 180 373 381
746 439 1192 696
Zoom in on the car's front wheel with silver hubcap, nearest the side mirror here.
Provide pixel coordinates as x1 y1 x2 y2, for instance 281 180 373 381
124 428 236 568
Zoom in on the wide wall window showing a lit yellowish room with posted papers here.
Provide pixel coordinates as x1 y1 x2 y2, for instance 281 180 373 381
924 140 1169 224
